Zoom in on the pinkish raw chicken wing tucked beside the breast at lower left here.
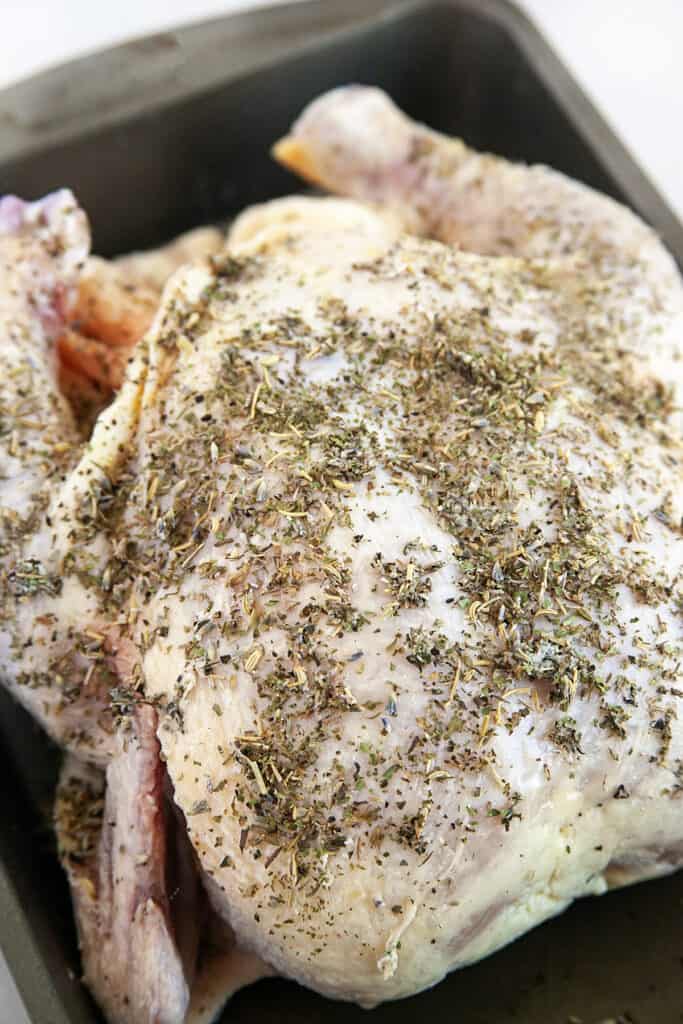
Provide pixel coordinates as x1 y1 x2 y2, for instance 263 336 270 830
55 706 272 1024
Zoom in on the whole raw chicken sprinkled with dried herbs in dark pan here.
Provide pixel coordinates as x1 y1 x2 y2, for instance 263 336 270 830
0 87 683 1024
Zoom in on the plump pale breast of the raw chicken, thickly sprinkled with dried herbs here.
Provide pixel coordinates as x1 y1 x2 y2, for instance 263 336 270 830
3 93 683 1020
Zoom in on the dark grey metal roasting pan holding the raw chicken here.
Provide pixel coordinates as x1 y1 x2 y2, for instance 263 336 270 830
0 0 683 1024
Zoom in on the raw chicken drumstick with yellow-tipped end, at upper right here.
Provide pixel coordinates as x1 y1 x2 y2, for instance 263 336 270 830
273 86 681 294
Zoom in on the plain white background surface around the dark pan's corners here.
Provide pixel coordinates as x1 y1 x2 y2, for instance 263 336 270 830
0 0 683 1024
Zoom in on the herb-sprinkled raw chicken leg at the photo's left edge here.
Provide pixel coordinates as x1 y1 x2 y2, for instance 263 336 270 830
0 191 115 761
